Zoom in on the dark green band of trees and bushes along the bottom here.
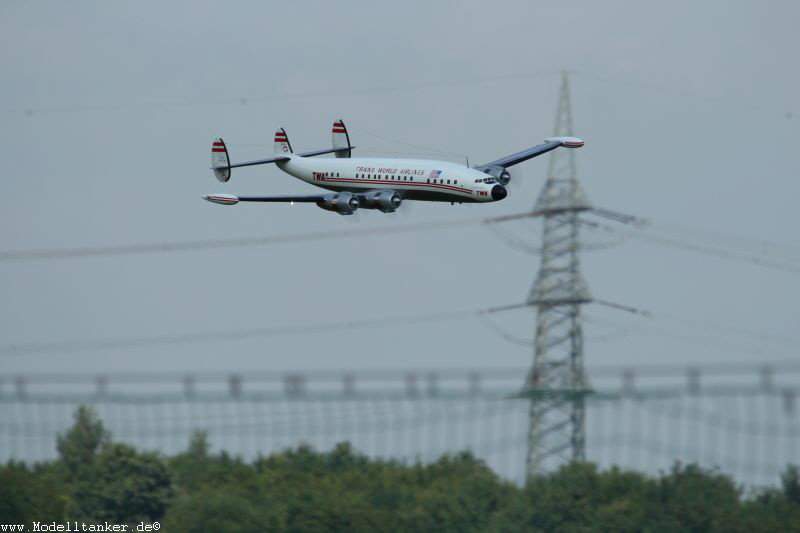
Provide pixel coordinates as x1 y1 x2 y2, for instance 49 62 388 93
0 408 800 533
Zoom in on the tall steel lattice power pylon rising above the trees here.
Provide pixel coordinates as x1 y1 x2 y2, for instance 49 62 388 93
525 73 592 477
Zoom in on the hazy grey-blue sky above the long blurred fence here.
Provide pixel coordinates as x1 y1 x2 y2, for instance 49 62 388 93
0 0 800 380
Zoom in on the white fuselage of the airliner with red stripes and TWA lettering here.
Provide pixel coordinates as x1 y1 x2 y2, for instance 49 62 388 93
276 156 505 202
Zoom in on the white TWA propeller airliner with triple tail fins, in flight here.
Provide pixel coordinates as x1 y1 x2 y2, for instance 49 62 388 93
203 120 583 215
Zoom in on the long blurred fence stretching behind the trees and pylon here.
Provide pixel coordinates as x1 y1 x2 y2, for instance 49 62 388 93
0 363 800 485
